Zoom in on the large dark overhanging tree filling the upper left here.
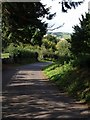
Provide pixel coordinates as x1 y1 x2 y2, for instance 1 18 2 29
2 2 49 47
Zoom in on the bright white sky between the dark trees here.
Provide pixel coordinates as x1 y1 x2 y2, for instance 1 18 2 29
41 0 90 33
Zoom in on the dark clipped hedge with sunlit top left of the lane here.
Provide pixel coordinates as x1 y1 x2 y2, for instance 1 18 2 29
2 44 38 63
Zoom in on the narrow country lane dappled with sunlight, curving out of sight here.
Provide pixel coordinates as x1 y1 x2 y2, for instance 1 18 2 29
2 62 89 120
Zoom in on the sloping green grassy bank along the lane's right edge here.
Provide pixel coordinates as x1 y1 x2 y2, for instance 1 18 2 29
44 62 90 104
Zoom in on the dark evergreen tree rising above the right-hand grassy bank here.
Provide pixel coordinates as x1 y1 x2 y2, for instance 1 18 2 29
71 13 90 56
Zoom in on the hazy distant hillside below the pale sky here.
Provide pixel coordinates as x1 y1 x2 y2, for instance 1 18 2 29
47 32 71 39
